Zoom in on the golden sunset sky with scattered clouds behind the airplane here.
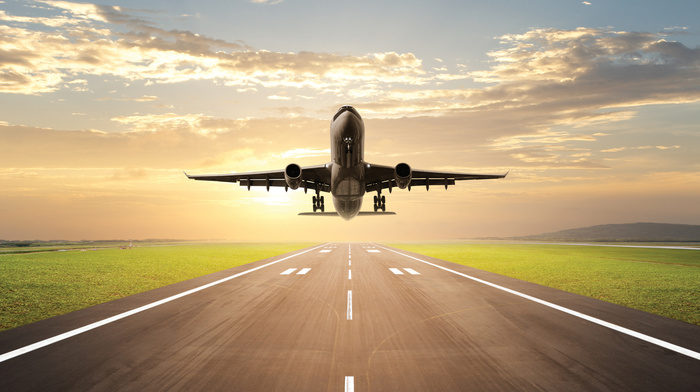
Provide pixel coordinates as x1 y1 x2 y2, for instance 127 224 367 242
0 0 700 242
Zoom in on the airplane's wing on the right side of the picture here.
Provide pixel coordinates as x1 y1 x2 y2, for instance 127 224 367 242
365 164 508 192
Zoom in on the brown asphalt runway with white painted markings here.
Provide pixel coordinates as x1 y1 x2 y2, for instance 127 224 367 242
0 243 700 391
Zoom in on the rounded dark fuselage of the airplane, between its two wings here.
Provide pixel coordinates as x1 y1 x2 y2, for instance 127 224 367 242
330 106 365 220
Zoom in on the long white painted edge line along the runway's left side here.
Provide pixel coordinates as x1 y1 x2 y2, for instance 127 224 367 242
0 245 325 362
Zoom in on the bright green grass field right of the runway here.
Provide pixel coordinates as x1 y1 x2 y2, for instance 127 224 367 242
391 244 700 325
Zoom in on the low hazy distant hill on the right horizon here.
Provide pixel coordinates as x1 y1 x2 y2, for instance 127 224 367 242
508 223 700 242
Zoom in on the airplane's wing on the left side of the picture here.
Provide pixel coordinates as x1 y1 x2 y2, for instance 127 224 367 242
185 165 331 192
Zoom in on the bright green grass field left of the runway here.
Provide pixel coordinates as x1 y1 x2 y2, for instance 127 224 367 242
0 244 310 331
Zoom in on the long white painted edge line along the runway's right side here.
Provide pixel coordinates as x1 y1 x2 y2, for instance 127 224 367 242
382 247 700 360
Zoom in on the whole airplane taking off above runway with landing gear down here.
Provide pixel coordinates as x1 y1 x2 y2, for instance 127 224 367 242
185 105 508 220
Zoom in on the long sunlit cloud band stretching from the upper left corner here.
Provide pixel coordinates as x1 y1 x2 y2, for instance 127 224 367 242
0 1 464 94
